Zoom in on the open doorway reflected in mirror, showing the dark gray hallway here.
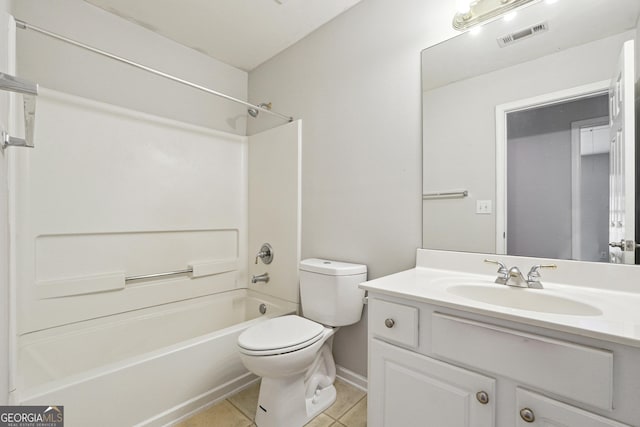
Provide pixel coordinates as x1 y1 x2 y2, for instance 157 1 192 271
497 93 609 261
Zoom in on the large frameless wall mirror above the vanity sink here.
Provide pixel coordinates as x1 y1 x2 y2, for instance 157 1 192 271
422 0 640 263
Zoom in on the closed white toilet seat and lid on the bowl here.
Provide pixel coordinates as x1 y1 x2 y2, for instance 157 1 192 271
238 315 325 356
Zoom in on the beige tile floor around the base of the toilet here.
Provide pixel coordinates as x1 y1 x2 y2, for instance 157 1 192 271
176 379 367 427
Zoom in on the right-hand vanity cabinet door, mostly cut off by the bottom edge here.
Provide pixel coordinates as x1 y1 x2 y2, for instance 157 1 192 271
516 388 629 427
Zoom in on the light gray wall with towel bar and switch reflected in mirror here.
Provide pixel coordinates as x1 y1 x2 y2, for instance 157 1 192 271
423 32 634 253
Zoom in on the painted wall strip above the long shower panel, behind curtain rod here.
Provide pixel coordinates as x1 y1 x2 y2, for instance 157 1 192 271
13 0 247 135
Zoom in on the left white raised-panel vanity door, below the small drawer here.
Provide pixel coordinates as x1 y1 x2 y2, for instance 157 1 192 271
368 339 495 427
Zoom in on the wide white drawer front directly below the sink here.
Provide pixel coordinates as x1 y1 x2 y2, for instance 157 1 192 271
431 313 613 411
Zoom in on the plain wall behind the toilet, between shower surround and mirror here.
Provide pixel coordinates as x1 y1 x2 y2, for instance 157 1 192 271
249 0 454 375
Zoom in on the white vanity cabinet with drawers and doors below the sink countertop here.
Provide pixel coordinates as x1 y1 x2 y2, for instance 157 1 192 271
368 296 640 427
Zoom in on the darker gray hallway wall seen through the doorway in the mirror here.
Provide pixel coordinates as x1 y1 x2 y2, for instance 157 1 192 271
507 95 609 259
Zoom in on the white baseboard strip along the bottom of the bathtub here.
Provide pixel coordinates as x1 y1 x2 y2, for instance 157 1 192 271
141 373 260 427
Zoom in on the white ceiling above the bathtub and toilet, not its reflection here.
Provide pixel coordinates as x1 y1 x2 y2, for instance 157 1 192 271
85 0 361 71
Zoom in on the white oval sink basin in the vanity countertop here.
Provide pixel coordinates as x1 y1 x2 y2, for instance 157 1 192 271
447 284 602 316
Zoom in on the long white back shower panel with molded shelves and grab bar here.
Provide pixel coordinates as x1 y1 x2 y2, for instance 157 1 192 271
11 89 247 334
